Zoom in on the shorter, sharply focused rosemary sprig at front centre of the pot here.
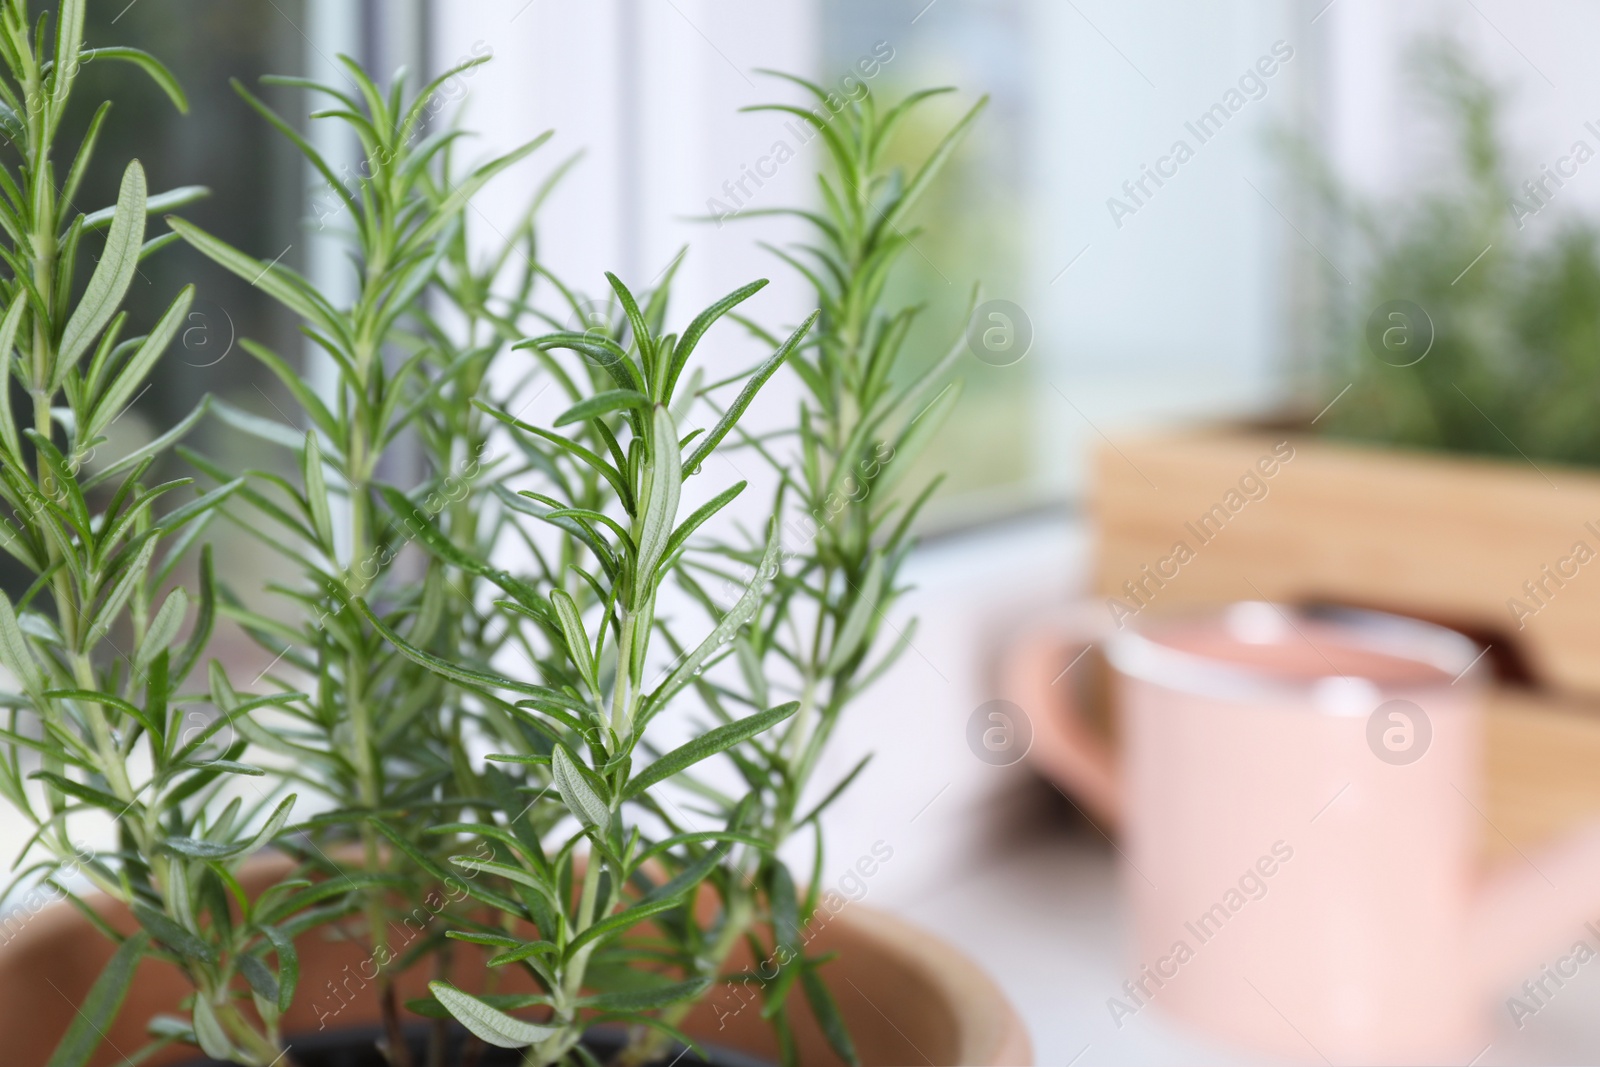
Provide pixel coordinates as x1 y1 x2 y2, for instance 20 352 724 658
370 268 816 1064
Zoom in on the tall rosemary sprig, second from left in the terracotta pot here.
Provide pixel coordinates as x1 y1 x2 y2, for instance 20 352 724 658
171 56 549 1067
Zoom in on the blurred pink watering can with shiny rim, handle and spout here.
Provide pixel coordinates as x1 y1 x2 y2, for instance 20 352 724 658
1006 603 1600 1064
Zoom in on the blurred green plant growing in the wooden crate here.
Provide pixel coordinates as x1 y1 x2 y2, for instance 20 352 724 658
1294 40 1600 466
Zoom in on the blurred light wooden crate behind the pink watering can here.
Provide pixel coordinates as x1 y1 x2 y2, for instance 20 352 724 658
1091 429 1600 854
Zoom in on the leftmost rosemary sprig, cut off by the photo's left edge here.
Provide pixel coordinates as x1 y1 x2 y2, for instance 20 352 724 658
0 0 318 1067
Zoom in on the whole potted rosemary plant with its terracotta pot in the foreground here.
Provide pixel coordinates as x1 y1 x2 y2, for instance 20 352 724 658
0 20 1027 1067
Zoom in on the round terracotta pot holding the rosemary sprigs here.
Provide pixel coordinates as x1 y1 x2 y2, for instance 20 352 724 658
0 861 1034 1067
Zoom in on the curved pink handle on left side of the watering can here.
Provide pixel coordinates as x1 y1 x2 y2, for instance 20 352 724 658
1000 605 1122 827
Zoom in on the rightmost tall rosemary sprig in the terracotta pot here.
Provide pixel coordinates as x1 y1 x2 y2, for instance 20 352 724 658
624 75 987 1064
